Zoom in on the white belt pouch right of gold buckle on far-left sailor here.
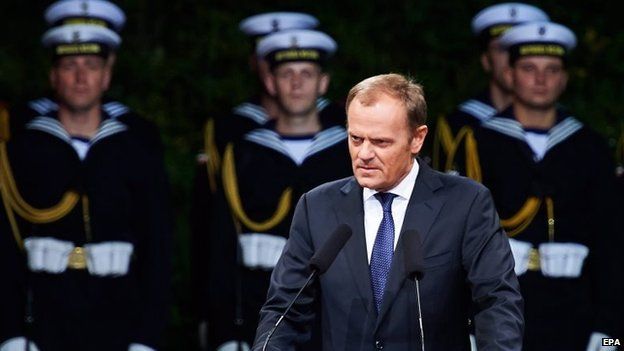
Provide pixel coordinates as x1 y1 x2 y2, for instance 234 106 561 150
85 241 134 277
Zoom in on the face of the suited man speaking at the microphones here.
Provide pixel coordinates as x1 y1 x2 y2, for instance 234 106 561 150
347 94 427 191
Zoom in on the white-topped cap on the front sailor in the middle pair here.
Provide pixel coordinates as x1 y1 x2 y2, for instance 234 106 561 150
256 29 338 67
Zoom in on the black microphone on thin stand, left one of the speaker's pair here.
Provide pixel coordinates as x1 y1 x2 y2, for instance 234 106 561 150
262 223 353 351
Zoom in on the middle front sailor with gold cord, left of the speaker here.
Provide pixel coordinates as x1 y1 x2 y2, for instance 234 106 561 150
196 29 351 351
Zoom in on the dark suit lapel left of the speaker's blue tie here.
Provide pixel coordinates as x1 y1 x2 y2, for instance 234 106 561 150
335 178 375 313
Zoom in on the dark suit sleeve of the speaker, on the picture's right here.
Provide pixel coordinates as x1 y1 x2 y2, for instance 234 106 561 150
462 188 524 351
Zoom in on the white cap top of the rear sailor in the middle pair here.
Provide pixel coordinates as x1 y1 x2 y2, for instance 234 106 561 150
238 12 319 37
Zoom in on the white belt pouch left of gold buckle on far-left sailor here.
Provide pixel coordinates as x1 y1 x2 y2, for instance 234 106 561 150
24 237 74 274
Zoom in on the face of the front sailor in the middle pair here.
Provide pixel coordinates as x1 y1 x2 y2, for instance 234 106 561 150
265 62 329 117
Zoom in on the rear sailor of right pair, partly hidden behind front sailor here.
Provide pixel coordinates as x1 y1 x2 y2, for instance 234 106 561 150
433 2 548 175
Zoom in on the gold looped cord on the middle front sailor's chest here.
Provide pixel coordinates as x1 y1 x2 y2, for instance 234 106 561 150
222 143 292 232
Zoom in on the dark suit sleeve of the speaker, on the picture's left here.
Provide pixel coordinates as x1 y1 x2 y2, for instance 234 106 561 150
253 194 318 351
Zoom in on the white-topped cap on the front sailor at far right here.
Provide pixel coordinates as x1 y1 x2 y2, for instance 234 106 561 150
500 22 576 63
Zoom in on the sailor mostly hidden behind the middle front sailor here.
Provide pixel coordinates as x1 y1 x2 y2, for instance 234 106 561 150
191 12 343 350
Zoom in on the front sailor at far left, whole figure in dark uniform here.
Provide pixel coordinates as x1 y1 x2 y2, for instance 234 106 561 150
0 13 171 351
